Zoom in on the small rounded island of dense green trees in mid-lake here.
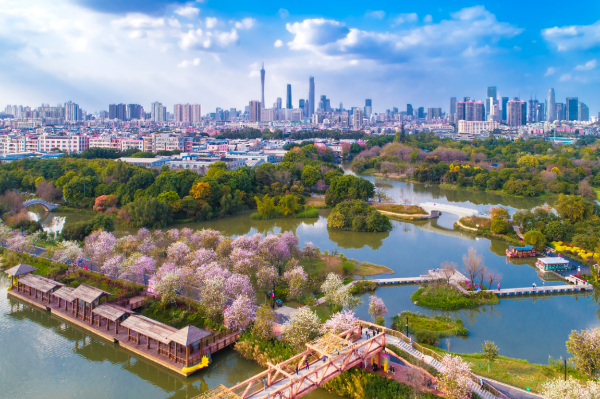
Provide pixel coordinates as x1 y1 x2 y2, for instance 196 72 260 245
327 200 392 233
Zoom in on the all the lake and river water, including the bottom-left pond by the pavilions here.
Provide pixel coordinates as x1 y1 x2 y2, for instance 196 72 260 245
9 176 600 398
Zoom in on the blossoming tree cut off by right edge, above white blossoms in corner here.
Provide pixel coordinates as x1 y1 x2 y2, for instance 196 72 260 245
567 328 600 378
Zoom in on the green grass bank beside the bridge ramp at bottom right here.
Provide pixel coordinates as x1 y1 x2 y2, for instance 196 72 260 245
427 346 584 392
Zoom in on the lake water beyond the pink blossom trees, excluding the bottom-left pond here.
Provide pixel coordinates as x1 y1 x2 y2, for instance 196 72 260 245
21 176 600 370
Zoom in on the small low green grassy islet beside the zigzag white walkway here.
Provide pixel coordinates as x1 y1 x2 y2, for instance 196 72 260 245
410 284 500 310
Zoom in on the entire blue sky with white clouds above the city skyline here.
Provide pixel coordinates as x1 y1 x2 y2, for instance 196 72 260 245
0 0 600 115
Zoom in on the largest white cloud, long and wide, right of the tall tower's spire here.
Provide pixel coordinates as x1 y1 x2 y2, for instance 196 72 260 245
286 6 522 62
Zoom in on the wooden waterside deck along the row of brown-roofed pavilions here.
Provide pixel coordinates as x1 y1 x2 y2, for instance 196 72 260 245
8 289 239 377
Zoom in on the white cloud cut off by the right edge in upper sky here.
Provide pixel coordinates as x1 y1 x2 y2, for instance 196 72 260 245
542 21 600 51
